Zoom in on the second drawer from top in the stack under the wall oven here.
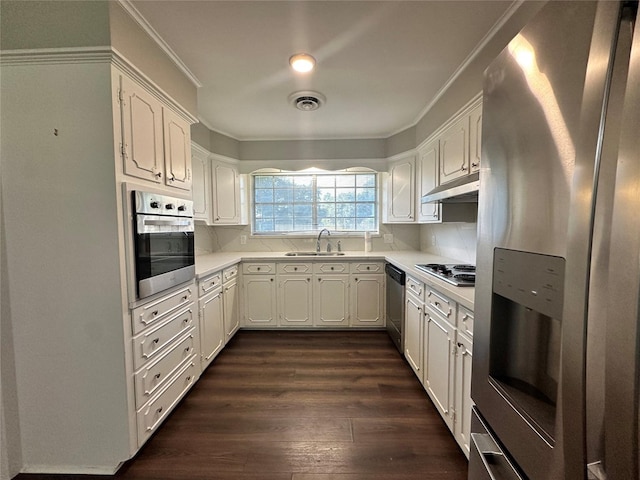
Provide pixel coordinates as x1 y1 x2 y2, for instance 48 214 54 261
133 308 193 370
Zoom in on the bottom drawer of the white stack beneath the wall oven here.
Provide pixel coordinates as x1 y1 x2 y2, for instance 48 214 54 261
136 357 198 446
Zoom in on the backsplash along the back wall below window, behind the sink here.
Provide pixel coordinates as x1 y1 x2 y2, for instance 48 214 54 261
195 224 420 255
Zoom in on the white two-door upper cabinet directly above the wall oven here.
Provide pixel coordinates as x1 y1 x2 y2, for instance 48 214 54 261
118 75 192 191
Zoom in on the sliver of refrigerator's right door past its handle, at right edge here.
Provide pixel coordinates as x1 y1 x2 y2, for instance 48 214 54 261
602 5 640 479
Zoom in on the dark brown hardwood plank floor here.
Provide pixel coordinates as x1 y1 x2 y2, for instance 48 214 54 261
16 331 467 480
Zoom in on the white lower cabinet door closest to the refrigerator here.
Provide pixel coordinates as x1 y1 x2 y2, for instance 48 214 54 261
453 332 473 458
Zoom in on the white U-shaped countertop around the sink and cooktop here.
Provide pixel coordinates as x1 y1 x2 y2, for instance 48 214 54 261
196 250 475 310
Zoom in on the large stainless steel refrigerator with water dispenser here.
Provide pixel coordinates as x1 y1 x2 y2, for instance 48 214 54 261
469 1 640 480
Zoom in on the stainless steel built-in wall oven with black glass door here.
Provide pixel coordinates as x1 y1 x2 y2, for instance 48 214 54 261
132 190 195 298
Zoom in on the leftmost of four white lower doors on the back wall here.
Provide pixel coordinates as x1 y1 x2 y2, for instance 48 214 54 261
243 275 278 327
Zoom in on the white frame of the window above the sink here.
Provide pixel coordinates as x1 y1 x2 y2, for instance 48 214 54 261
248 167 382 238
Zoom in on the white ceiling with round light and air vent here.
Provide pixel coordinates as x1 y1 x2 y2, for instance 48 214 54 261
130 0 513 140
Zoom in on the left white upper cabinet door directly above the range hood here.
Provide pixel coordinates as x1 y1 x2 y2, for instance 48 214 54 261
440 116 469 184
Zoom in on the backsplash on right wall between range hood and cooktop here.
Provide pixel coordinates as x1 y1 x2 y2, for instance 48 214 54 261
420 223 478 265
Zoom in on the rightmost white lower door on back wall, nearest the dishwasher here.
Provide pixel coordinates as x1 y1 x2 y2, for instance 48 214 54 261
350 275 385 327
